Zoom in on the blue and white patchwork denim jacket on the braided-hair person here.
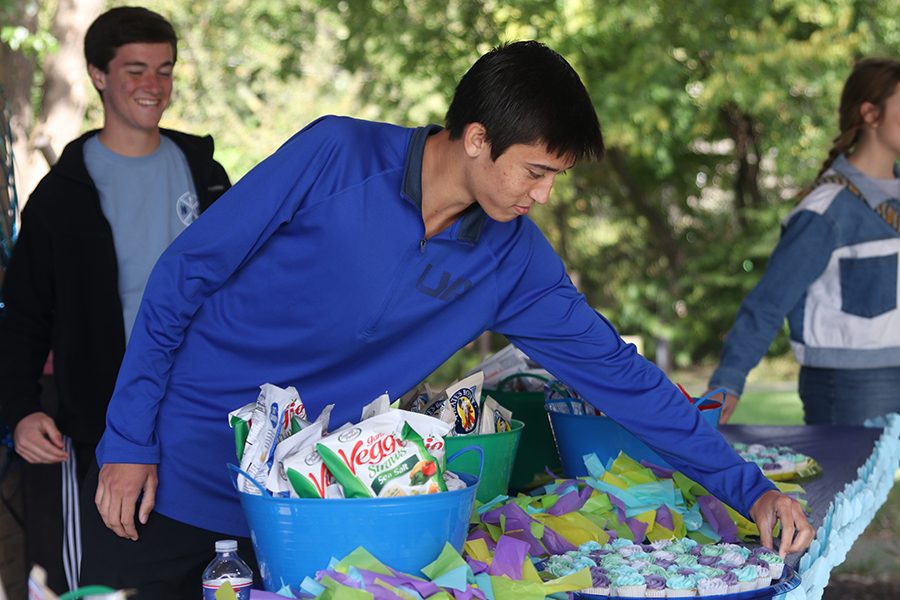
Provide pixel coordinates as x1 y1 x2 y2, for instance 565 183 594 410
710 155 900 394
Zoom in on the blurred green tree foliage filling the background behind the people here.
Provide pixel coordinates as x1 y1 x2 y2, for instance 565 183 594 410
7 0 900 376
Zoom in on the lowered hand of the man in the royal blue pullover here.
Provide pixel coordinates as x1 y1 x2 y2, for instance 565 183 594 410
94 463 157 540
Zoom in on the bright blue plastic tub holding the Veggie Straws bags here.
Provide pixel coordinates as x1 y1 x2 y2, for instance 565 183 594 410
228 448 481 592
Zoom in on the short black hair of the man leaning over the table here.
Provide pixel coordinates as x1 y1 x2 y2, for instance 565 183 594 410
445 41 604 160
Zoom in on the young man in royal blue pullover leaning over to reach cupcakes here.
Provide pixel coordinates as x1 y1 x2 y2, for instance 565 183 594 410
82 42 813 590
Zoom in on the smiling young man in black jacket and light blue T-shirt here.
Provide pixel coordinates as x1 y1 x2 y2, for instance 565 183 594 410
0 7 230 591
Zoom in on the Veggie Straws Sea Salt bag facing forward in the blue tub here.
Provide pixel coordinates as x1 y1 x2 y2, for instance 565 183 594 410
316 410 450 498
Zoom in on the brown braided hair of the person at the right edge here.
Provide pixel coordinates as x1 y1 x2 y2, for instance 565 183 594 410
816 58 900 179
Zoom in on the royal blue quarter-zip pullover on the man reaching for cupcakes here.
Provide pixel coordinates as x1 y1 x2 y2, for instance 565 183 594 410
97 117 773 535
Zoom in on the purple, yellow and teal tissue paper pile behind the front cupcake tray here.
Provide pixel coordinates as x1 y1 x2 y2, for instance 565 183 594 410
469 453 803 558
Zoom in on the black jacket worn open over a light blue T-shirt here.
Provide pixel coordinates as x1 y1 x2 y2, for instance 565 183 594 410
0 129 231 444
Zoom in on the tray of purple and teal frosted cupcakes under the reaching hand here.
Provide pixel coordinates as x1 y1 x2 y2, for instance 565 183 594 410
540 538 800 600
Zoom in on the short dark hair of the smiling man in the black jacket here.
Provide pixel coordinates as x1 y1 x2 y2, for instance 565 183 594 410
84 6 178 73
